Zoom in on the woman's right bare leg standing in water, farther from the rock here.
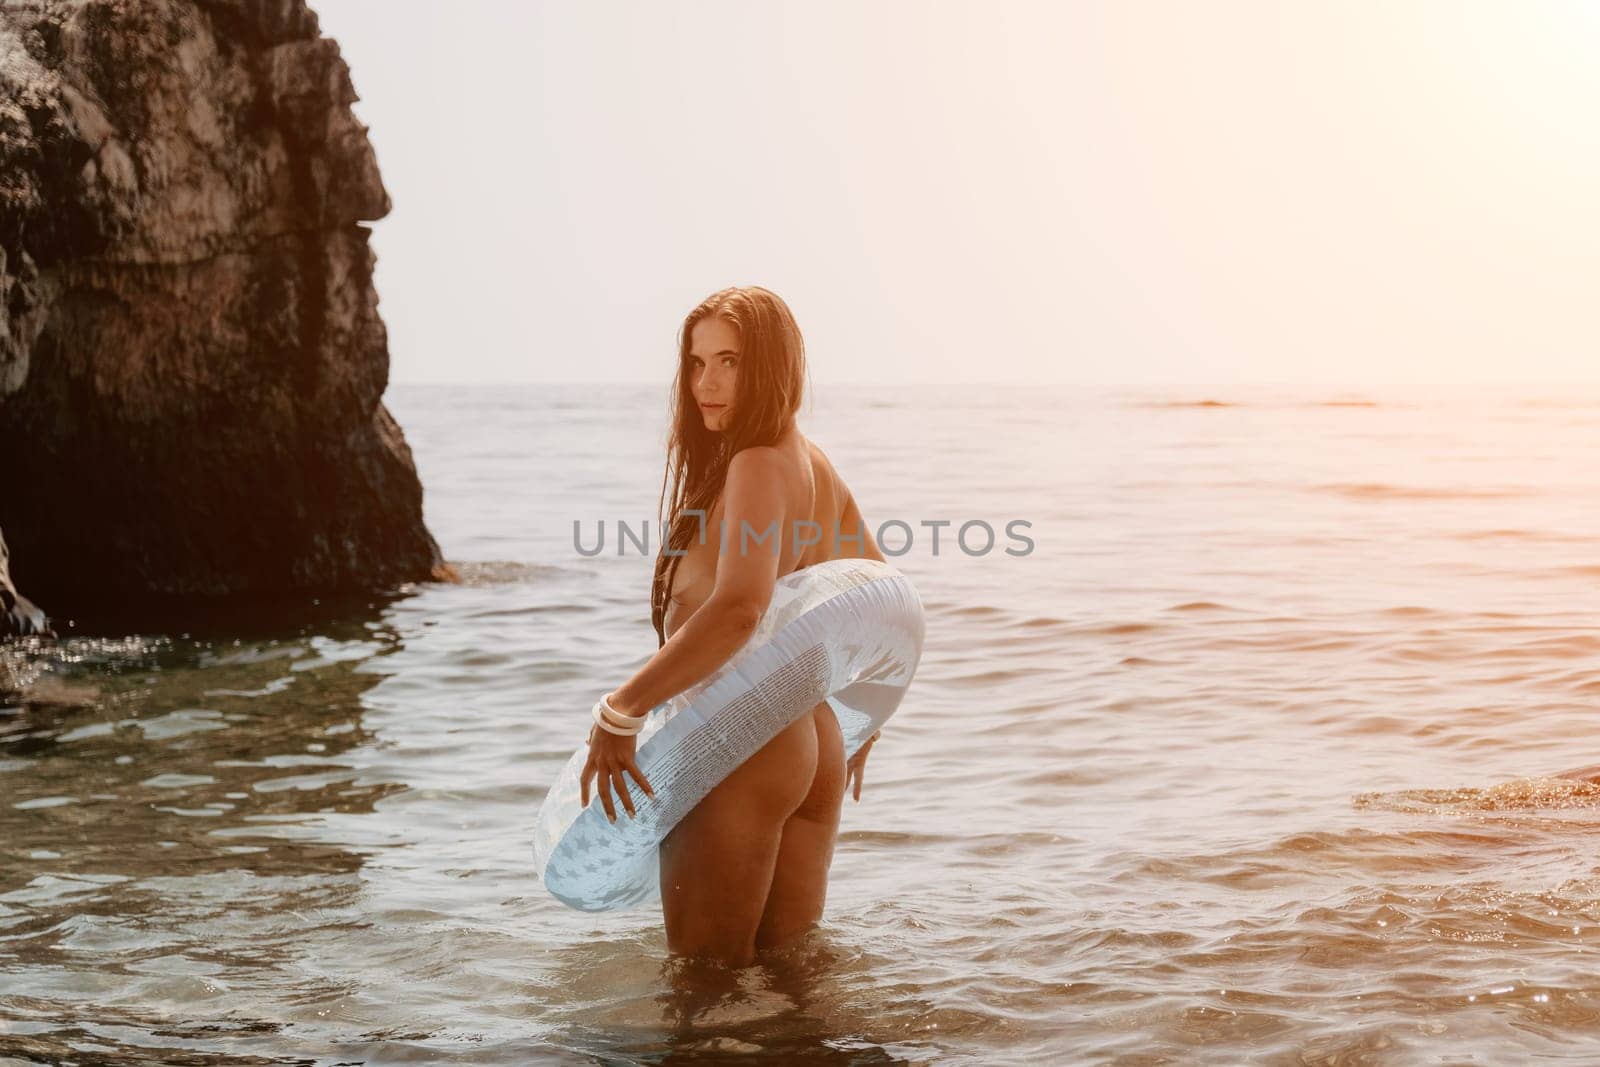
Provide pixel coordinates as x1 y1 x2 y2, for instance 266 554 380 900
755 701 846 949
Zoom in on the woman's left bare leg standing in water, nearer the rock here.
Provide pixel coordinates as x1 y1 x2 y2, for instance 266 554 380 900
661 715 818 966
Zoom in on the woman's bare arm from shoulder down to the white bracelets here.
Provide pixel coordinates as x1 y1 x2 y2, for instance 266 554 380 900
611 448 787 715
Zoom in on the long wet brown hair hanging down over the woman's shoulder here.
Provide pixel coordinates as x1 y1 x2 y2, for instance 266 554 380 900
650 285 806 645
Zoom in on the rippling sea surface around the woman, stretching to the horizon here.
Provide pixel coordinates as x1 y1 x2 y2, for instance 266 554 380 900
0 386 1600 1065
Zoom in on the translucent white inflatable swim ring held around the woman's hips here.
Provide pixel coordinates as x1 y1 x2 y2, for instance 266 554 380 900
533 560 923 912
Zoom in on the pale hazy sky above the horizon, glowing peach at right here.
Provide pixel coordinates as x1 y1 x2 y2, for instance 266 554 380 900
310 0 1600 386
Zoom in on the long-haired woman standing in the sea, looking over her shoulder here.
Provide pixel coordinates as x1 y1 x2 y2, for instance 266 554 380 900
582 286 883 968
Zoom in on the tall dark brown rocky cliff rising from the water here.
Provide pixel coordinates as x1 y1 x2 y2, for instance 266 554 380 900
0 0 448 633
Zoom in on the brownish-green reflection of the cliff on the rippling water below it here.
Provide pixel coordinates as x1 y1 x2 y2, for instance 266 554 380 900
0 603 403 1062
